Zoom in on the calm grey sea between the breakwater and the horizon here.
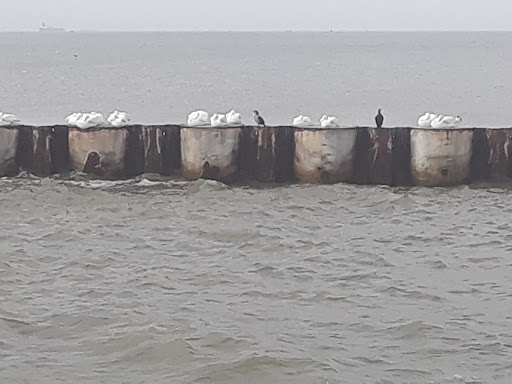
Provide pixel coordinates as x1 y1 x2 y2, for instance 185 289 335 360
0 33 512 127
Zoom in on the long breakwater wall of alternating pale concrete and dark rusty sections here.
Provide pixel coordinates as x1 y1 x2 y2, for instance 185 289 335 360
0 125 512 186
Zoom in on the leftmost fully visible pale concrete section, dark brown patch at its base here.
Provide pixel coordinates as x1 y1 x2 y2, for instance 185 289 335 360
69 128 129 178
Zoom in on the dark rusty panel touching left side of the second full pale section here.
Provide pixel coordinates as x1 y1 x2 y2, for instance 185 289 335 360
142 125 181 176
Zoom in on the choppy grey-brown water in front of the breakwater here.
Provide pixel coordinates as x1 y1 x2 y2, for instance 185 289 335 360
0 176 512 384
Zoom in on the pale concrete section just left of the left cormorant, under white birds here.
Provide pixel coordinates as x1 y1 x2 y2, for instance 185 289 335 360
181 127 242 181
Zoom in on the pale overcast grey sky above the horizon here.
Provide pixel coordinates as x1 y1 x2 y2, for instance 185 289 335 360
0 0 512 31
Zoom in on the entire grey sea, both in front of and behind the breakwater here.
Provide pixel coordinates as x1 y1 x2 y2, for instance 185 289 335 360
0 33 512 384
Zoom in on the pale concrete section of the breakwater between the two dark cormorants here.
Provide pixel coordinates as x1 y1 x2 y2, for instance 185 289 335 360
295 128 357 183
